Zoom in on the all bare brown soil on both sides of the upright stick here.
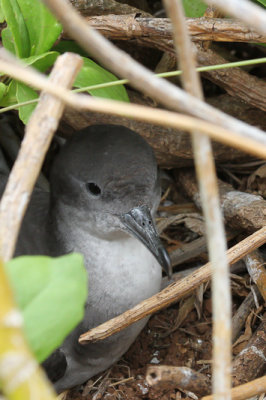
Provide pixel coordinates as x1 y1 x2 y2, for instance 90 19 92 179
66 266 261 400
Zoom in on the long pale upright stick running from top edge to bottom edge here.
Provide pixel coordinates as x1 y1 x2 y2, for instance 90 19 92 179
164 0 231 399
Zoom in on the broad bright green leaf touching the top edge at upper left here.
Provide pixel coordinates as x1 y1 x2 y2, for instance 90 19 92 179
17 0 62 56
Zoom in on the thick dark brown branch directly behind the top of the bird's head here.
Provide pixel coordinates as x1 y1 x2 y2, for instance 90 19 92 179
60 90 266 168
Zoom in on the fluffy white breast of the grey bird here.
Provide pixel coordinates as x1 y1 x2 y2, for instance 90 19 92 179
79 236 162 324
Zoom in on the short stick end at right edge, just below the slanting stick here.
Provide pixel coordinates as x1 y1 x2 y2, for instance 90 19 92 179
244 251 266 301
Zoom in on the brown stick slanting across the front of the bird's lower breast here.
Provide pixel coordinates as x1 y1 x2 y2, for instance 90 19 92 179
79 226 266 344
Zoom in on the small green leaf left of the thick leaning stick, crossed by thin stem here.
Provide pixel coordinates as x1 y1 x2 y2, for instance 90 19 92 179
16 81 39 125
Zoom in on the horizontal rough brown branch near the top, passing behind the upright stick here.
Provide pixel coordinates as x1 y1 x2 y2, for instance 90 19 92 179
80 14 266 43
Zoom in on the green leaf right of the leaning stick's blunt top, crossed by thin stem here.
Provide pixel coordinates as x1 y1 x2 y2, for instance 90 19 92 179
73 57 129 102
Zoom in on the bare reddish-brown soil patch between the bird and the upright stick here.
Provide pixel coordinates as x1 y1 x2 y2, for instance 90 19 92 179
64 299 212 400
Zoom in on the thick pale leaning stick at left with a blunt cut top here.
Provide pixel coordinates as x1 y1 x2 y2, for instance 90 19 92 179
0 53 82 261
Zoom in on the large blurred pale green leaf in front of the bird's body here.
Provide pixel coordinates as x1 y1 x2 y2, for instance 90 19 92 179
6 253 87 362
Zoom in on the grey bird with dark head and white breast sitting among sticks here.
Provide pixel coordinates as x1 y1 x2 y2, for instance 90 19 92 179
0 125 171 393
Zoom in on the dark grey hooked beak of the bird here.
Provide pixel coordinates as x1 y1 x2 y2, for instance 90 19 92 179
120 205 172 279
